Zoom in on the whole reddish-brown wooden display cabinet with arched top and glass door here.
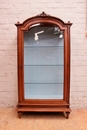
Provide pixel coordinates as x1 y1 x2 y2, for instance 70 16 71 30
15 12 72 118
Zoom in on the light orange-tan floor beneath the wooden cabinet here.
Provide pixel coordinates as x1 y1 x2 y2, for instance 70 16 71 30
0 108 87 130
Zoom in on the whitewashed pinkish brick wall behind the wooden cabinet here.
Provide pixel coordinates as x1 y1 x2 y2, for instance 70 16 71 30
0 0 87 108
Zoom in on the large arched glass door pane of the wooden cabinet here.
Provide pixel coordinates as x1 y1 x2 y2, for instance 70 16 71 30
24 25 64 99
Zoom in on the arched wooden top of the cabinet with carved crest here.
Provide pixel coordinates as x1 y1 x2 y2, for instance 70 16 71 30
15 12 72 30
